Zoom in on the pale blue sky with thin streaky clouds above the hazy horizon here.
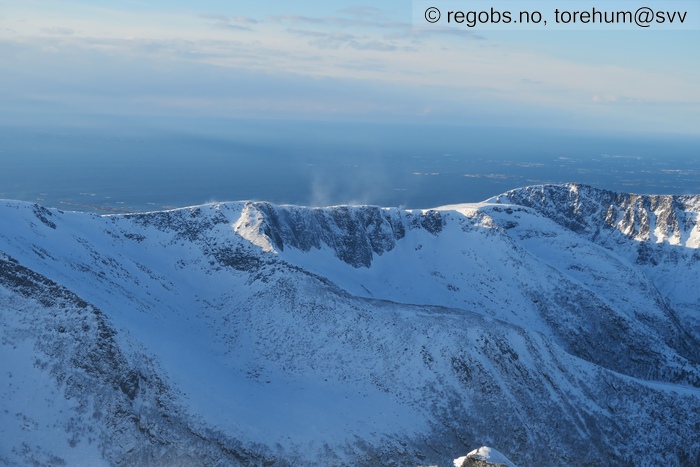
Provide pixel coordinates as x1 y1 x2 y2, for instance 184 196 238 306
0 0 700 135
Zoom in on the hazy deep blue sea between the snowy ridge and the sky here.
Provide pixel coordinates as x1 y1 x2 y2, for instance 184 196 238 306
0 120 700 213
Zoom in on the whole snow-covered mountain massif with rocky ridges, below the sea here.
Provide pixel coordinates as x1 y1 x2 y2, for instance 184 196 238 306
0 185 700 466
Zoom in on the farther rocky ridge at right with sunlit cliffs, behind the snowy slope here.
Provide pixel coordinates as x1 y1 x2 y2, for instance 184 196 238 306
493 184 700 339
